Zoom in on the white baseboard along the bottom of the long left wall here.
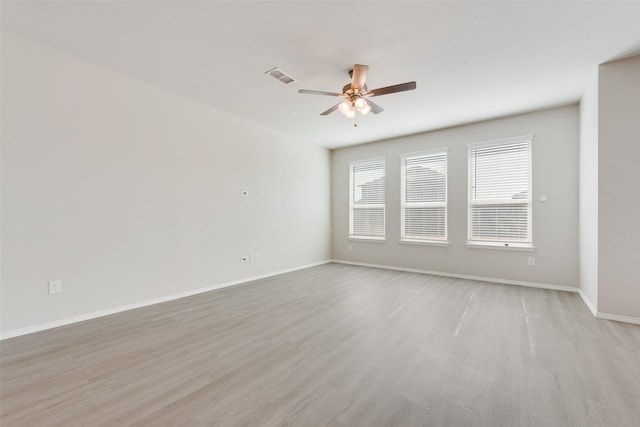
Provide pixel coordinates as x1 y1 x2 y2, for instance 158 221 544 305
0 260 332 341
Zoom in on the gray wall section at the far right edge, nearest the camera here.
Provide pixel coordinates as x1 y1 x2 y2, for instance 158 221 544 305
598 56 640 321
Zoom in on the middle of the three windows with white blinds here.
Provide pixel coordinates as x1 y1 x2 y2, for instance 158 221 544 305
400 148 447 243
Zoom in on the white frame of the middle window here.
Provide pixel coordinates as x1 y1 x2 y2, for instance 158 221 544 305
400 147 449 246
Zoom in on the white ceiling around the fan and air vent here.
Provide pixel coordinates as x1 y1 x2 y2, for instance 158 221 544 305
2 1 640 148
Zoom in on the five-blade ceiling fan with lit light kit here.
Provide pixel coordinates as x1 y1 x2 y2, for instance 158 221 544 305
298 64 416 118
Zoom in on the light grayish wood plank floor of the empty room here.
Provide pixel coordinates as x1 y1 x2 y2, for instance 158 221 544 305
0 264 640 427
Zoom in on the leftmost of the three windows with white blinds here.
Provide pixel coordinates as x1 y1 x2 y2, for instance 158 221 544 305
349 157 385 240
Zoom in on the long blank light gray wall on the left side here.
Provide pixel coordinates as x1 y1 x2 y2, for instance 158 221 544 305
0 33 330 332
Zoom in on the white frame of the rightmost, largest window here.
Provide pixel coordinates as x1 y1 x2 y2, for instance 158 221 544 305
466 134 535 250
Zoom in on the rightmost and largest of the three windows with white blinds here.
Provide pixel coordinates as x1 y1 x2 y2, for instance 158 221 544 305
467 135 532 247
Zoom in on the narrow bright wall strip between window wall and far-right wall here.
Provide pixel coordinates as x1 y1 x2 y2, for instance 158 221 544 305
579 71 598 312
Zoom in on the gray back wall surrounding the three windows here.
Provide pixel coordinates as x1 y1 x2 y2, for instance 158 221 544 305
331 105 579 287
